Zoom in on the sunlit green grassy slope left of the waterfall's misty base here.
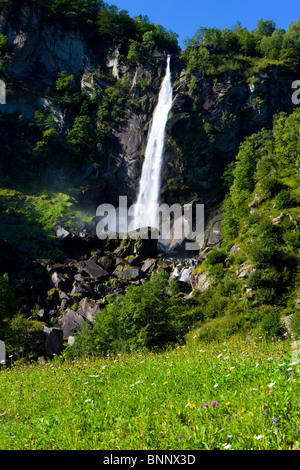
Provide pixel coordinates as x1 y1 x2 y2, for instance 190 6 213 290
0 185 92 257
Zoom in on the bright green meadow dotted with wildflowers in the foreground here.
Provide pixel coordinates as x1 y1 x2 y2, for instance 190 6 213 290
0 338 300 450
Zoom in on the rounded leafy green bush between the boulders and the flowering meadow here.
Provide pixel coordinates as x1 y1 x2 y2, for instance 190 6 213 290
69 273 190 355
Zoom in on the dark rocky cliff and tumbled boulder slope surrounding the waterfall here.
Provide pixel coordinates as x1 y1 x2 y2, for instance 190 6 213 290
0 2 297 355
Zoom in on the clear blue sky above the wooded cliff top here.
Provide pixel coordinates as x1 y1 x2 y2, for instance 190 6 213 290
106 0 300 47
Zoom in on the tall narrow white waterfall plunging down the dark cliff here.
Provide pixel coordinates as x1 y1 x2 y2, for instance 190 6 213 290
134 56 173 228
